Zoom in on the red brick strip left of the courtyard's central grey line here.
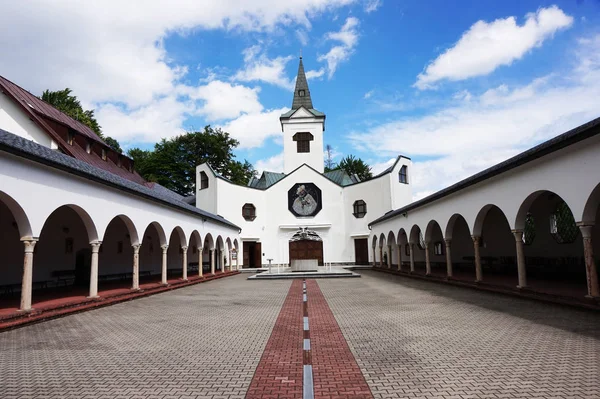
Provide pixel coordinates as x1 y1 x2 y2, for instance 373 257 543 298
246 280 303 399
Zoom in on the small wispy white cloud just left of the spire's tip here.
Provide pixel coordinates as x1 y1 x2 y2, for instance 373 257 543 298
232 45 294 90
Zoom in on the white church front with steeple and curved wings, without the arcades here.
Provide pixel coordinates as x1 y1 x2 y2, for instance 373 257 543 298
196 59 412 267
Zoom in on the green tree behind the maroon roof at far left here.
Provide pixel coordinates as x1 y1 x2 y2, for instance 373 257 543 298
41 87 123 153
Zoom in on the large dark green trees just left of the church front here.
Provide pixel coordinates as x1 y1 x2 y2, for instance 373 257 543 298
127 126 256 195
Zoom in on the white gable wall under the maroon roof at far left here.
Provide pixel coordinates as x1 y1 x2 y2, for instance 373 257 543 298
0 92 58 149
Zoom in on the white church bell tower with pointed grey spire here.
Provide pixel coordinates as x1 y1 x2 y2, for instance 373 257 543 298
279 57 325 174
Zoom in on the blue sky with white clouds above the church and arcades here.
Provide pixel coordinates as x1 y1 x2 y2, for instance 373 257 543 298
0 0 600 198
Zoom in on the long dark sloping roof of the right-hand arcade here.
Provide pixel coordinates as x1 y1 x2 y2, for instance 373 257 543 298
369 118 600 226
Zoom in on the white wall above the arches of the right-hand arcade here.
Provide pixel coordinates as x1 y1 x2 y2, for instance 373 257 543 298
371 136 600 255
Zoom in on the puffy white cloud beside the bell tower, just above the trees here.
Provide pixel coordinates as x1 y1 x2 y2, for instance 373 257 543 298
222 108 289 149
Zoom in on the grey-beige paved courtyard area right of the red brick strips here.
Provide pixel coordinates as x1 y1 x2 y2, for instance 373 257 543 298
319 271 600 399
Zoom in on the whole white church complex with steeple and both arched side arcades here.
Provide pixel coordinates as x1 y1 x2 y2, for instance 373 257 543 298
0 55 600 322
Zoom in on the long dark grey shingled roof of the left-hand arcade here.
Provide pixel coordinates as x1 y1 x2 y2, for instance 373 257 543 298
0 129 240 230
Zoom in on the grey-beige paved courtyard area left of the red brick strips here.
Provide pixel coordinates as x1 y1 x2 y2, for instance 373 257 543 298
0 275 291 399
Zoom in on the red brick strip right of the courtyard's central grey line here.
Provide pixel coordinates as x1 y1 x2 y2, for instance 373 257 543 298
306 280 373 399
